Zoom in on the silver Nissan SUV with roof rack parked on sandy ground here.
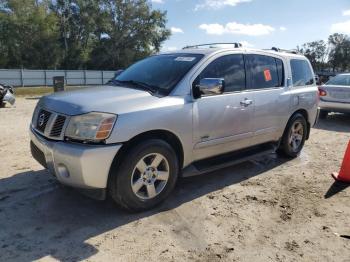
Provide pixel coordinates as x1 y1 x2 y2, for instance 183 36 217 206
30 44 319 211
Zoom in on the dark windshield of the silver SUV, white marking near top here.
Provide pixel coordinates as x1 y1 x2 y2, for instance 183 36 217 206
114 54 203 95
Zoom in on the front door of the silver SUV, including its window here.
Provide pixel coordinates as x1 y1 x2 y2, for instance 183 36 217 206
193 54 254 160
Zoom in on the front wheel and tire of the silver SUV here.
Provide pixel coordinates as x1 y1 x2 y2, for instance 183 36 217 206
108 139 179 212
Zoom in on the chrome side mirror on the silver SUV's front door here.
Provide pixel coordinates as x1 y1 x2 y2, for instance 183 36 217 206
193 78 225 98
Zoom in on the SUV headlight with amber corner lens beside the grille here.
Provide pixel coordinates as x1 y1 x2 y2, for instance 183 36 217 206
65 112 117 141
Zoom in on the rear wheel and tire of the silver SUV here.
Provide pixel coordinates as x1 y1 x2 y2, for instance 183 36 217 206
277 113 308 158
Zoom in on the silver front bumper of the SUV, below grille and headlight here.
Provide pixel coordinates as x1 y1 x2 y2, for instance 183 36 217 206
30 128 122 190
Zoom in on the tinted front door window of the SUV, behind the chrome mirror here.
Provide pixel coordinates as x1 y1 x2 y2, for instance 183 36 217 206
195 55 245 92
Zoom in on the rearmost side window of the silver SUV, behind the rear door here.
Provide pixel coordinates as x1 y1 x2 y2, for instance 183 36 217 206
290 59 314 86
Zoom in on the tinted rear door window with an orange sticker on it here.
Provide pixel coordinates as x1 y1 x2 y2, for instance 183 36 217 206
247 55 284 89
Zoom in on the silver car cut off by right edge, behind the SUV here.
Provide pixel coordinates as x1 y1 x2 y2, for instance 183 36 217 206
319 73 350 118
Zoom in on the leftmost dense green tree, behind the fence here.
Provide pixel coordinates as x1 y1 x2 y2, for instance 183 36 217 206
0 0 60 69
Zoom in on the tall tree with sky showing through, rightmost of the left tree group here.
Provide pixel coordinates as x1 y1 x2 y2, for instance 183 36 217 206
89 0 170 69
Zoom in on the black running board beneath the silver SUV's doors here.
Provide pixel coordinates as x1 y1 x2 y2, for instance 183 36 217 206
182 143 277 177
